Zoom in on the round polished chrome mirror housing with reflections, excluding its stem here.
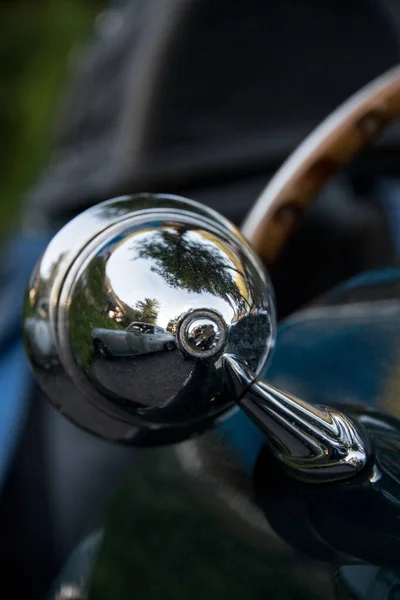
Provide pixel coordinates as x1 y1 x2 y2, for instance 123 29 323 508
24 195 275 444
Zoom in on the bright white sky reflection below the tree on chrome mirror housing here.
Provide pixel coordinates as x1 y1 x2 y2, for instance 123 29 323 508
106 234 238 327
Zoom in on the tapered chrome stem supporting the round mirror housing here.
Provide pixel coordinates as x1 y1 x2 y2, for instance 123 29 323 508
224 355 372 483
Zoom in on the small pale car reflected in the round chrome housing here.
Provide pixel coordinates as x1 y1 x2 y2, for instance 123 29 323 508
92 322 175 356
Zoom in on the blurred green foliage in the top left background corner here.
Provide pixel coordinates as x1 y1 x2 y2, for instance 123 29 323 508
0 0 103 235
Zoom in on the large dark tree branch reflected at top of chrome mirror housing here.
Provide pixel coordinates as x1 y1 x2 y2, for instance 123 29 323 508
135 231 244 306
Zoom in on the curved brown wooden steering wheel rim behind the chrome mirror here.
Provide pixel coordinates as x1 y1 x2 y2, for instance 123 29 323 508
242 66 400 266
